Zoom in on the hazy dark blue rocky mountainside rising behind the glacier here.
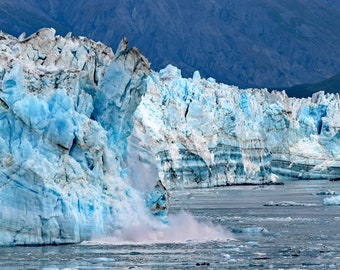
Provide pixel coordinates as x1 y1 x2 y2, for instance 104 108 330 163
0 0 340 90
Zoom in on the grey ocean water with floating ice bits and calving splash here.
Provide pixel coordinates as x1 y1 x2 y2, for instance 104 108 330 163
0 181 340 270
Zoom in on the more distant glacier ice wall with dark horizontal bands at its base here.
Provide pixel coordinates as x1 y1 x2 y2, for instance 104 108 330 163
129 65 340 187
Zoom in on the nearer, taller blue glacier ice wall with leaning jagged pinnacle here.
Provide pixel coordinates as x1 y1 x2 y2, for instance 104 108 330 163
0 29 156 245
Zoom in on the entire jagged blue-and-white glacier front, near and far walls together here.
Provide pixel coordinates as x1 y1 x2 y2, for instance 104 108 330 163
0 28 340 245
